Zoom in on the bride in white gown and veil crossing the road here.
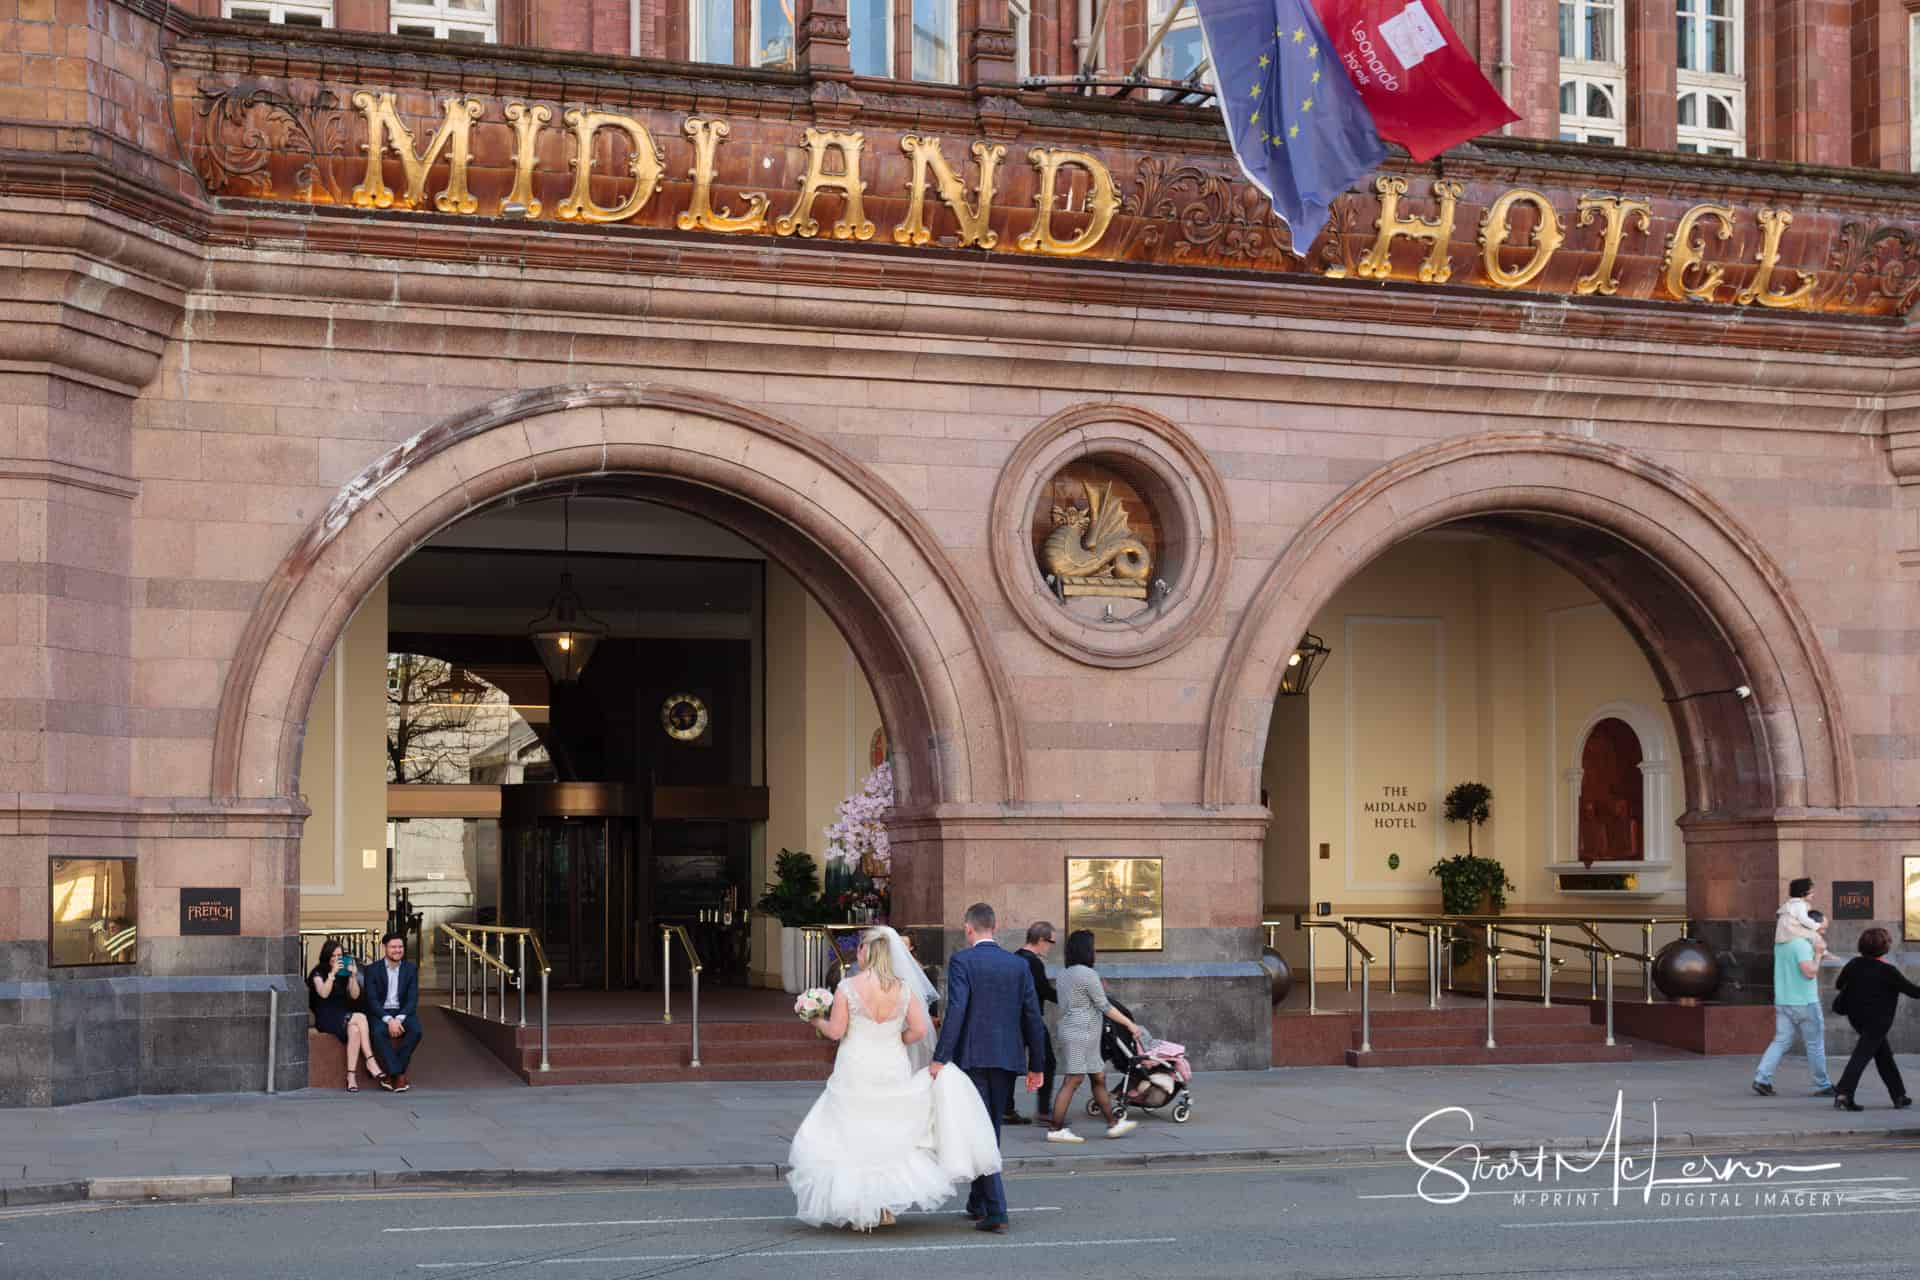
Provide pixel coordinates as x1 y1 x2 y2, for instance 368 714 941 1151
787 927 1000 1230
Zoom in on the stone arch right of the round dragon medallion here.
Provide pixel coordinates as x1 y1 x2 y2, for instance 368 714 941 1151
1204 432 1857 816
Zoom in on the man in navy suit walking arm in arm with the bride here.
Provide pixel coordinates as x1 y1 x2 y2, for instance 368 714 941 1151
927 902 1046 1236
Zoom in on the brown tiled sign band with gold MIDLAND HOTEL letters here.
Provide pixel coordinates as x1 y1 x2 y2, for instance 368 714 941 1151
175 77 1920 315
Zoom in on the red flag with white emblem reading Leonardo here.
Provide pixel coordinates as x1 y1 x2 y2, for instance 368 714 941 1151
1313 0 1521 159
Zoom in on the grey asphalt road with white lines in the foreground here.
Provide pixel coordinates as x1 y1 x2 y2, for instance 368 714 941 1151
0 1144 1920 1280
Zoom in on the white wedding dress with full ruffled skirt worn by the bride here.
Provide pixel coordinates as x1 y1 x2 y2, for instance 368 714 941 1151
787 983 1000 1230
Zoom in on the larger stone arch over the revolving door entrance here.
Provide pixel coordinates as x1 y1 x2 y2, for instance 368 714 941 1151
211 382 1025 810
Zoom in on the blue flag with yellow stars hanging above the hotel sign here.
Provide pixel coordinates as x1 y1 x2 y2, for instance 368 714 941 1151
1194 0 1386 253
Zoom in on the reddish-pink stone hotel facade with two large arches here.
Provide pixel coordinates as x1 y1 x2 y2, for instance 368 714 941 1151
0 0 1920 1105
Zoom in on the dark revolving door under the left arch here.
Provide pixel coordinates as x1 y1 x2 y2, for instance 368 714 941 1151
499 783 647 990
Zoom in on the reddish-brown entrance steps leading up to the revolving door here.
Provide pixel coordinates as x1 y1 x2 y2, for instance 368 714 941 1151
447 1009 835 1084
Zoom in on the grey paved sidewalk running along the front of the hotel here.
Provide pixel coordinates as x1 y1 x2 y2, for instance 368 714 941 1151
0 1057 1920 1203
